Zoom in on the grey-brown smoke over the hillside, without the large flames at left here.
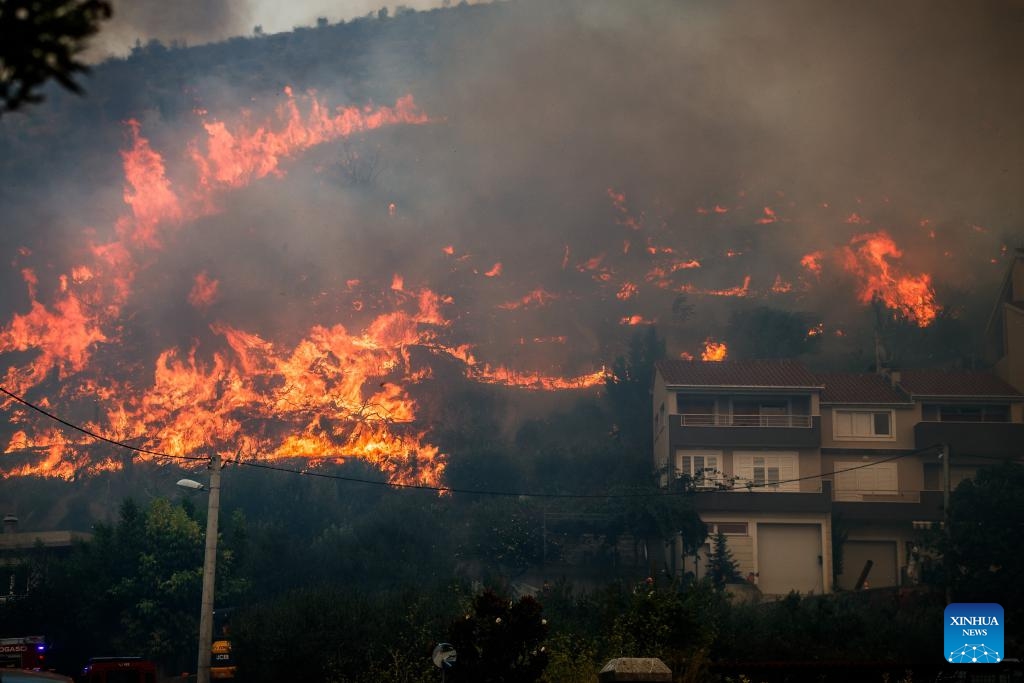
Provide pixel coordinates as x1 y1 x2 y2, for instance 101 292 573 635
0 0 1024 481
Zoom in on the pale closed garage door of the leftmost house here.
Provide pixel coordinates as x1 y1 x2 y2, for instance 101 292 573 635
758 524 824 595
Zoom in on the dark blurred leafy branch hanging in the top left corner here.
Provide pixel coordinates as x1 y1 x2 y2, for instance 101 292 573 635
0 0 112 114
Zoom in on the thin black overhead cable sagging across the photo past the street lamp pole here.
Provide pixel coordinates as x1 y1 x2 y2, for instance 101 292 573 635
0 387 939 500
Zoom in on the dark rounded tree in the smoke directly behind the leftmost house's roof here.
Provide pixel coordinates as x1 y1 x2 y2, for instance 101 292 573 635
727 306 821 359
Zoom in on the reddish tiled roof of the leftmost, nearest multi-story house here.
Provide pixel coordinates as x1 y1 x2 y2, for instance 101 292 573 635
656 360 821 389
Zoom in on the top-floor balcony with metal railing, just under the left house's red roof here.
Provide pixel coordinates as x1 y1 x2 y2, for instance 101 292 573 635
669 413 821 449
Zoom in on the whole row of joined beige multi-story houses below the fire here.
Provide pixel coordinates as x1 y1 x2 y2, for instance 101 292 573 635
653 360 1024 595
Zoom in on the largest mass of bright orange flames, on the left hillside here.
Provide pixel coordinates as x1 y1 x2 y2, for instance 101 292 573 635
0 90 444 484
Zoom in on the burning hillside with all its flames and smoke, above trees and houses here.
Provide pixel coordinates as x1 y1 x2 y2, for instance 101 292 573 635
0 0 1024 481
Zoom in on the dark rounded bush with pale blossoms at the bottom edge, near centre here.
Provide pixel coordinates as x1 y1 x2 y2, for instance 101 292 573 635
449 590 548 683
